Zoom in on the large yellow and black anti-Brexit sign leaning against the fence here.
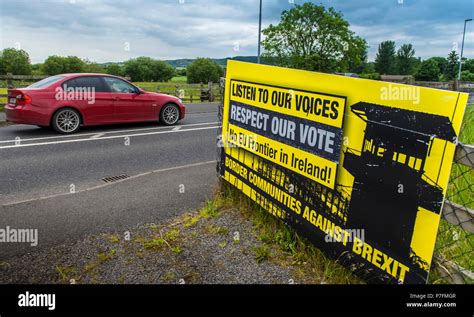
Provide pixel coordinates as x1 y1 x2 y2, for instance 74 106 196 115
218 61 468 283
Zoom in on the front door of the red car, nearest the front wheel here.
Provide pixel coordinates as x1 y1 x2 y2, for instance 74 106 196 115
104 76 153 122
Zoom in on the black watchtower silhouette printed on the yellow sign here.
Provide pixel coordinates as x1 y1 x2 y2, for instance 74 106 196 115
343 102 456 259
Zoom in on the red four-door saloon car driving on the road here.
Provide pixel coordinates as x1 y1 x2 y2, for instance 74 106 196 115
5 74 185 133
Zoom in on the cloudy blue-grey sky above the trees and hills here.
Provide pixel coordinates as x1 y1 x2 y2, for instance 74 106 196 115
0 0 474 63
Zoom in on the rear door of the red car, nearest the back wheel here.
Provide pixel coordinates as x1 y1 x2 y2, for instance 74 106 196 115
62 76 115 124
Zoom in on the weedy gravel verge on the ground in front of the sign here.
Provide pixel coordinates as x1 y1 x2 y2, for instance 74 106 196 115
0 205 296 284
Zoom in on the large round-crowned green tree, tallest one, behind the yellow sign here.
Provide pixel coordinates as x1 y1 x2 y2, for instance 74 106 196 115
262 2 367 72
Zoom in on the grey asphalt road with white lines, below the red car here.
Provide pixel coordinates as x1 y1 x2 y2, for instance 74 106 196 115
0 104 218 260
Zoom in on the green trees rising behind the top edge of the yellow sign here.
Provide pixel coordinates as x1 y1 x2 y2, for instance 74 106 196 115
262 2 474 81
